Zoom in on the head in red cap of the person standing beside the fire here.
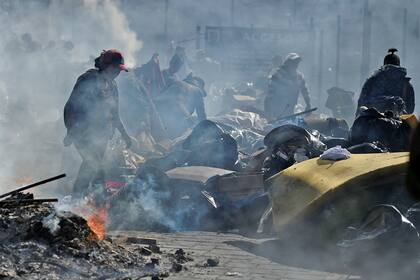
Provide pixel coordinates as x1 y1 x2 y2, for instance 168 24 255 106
95 49 128 79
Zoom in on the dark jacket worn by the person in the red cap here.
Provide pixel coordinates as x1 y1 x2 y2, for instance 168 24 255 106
64 69 121 140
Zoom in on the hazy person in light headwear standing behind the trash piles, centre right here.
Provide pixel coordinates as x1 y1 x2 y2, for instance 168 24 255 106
264 53 311 119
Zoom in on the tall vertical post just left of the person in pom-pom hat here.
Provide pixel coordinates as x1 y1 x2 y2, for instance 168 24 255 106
360 0 372 85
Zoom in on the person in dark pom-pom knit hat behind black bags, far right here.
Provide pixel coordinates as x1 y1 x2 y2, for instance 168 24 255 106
357 49 415 115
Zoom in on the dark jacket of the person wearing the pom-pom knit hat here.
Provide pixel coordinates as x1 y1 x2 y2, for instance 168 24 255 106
358 64 415 114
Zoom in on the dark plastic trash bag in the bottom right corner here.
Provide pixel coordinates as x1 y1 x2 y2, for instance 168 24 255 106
337 204 420 279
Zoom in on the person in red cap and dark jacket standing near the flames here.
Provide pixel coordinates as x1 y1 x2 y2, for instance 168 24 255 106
64 49 131 197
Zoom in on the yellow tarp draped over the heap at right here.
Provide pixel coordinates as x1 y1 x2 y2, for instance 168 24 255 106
268 153 409 232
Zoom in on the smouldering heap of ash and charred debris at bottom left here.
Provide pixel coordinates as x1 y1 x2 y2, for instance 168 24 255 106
0 176 199 279
